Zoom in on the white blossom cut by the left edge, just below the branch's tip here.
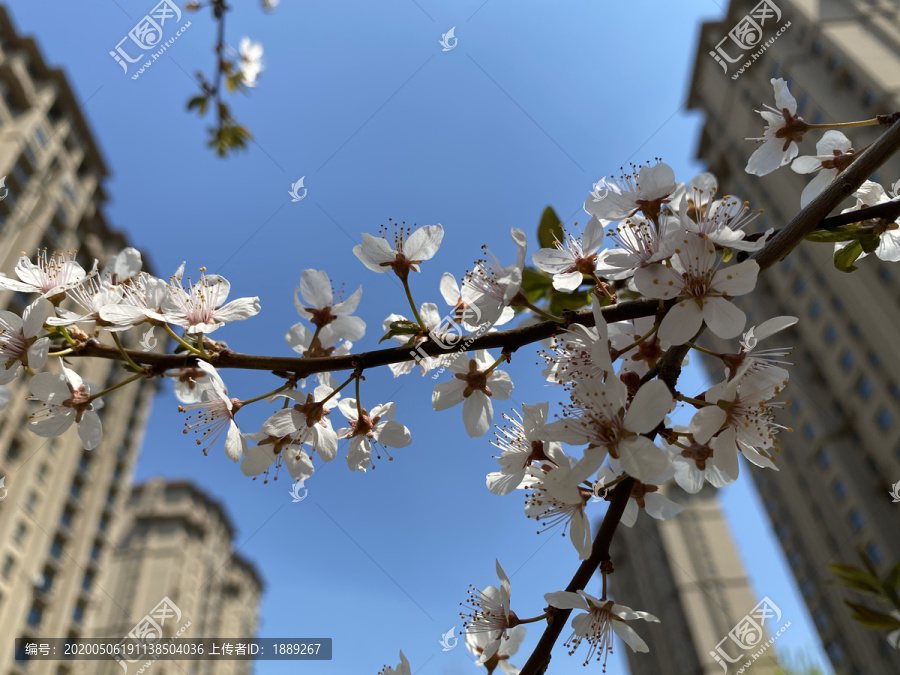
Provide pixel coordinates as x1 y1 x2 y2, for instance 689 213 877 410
0 298 50 384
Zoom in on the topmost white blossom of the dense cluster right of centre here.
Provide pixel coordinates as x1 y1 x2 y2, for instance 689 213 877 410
584 162 676 220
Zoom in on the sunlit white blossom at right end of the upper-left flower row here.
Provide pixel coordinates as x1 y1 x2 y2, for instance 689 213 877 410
163 263 260 333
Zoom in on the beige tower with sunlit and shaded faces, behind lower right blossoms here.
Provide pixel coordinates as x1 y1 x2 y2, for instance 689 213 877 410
611 483 778 675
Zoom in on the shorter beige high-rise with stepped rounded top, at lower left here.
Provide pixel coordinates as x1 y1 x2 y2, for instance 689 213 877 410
81 478 263 675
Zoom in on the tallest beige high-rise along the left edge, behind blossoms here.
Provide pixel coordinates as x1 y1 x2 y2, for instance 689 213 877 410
0 7 162 675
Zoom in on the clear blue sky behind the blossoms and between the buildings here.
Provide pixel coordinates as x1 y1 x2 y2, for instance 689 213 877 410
12 0 819 675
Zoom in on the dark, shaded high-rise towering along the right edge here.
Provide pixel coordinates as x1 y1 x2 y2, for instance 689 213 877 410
688 0 900 675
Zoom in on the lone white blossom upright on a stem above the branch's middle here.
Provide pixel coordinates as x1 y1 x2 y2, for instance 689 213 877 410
353 221 444 281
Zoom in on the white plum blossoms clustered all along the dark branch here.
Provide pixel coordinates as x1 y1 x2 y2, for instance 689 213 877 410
0 119 900 675
